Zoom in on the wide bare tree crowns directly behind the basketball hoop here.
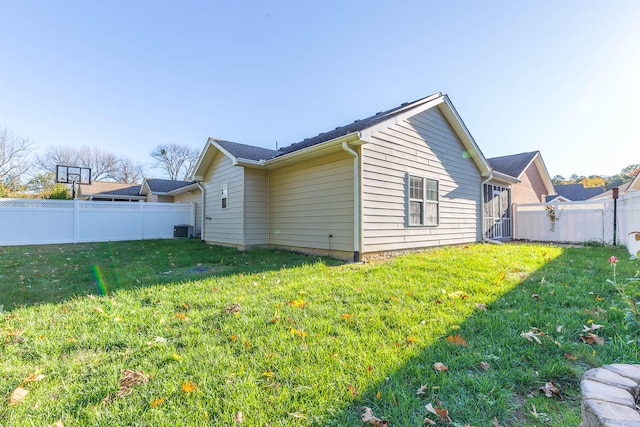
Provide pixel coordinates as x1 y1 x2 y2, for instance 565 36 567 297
37 146 142 184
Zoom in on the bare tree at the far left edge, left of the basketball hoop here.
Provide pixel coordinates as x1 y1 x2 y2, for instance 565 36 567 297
0 128 33 190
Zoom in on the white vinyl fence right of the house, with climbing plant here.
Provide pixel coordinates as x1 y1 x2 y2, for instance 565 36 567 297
514 192 640 255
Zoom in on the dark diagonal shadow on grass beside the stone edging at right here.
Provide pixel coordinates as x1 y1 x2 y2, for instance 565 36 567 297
320 248 638 426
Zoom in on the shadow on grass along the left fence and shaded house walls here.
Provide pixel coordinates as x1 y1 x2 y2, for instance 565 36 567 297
0 239 341 311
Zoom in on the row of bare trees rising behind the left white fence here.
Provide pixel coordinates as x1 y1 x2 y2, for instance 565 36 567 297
0 127 200 199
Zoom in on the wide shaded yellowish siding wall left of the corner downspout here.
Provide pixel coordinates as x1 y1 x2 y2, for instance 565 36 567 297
269 152 353 252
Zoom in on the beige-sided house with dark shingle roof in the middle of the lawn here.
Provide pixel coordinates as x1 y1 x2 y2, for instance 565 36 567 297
193 93 518 261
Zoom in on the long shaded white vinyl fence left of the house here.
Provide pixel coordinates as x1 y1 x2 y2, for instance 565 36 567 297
0 199 194 246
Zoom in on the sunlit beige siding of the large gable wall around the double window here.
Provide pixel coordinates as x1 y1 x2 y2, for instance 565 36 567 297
362 108 482 253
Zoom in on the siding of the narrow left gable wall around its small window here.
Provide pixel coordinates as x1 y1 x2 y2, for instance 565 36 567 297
204 152 244 246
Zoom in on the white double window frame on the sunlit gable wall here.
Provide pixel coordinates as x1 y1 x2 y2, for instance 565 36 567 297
407 174 440 227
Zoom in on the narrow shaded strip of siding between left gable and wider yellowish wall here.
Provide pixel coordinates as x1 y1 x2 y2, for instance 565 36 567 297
244 168 269 246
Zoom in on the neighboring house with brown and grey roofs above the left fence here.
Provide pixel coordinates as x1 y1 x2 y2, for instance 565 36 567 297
78 178 202 236
